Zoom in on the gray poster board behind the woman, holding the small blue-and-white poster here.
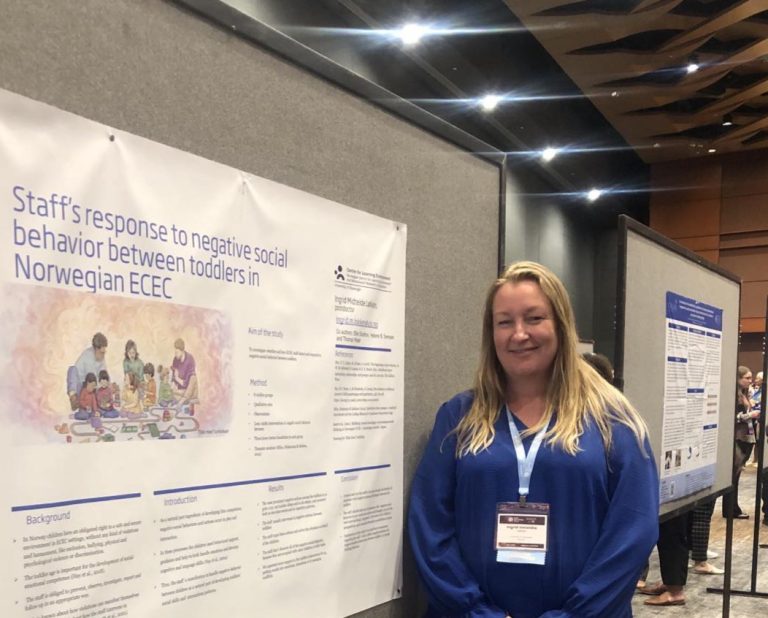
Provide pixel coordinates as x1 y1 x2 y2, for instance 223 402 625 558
617 219 740 515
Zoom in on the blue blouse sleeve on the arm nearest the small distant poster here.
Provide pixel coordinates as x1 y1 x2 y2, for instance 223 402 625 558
541 424 659 618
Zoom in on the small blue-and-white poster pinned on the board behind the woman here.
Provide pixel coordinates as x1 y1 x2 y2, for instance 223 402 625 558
659 292 723 504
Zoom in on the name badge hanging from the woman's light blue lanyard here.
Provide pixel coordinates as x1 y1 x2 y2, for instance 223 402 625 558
494 502 549 564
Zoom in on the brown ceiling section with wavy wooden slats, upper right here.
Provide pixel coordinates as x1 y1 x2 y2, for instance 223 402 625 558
505 0 768 163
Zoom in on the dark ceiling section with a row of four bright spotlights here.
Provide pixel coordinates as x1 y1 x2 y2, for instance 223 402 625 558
206 0 648 225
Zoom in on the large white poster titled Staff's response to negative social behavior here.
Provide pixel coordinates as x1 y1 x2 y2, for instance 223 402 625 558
0 86 406 618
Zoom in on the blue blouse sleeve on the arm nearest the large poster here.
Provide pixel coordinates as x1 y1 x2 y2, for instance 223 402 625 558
408 399 506 618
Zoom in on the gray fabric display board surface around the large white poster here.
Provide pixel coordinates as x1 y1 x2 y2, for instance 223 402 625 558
0 0 499 618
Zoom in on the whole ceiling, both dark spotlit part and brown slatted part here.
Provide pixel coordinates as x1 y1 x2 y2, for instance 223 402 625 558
195 0 768 180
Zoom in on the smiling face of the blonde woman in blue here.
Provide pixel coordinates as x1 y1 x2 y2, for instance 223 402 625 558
492 281 558 383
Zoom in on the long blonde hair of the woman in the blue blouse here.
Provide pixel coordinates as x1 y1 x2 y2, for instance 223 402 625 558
454 262 648 457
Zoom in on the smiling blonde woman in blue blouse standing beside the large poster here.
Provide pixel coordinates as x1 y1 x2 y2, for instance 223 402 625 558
409 262 659 618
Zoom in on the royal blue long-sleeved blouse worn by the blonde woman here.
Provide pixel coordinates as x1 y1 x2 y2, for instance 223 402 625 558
408 392 659 618
